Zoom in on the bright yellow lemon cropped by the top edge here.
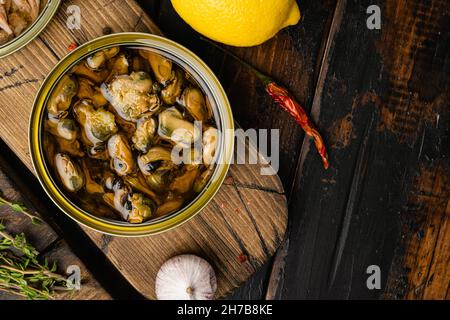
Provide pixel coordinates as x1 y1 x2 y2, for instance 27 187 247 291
172 0 300 47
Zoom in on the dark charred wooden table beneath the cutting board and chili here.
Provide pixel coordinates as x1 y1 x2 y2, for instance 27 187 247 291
2 0 450 299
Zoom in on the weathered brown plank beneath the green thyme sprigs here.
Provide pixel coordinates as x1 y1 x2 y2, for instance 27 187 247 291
0 152 111 300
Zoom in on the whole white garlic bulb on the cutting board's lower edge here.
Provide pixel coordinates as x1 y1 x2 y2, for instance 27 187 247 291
155 254 217 300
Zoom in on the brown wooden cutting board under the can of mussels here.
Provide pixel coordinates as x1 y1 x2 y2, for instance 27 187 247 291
0 0 287 298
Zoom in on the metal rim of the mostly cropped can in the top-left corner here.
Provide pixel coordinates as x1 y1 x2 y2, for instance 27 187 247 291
0 0 61 58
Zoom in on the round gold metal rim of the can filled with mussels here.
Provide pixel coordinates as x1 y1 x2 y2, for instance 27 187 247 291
29 33 234 236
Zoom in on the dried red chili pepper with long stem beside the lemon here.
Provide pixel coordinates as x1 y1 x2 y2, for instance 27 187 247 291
202 38 329 169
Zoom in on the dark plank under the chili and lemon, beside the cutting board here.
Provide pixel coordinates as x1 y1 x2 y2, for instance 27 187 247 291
154 0 335 299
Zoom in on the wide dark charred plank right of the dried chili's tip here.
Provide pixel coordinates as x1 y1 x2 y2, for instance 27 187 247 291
270 0 450 299
